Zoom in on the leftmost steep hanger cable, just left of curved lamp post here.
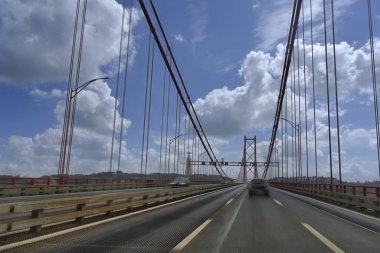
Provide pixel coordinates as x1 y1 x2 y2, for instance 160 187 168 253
57 0 81 175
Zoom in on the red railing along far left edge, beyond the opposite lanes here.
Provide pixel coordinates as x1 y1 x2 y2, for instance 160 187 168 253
0 177 220 186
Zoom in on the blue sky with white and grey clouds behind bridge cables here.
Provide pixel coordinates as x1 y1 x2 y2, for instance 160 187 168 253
0 0 380 181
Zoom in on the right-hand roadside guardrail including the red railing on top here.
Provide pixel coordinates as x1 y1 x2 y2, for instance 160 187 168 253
271 182 380 213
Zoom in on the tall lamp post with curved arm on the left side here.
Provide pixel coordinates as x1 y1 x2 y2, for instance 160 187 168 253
58 77 109 184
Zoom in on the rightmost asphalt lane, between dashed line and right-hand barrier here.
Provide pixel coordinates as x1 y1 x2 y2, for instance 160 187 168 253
272 189 380 252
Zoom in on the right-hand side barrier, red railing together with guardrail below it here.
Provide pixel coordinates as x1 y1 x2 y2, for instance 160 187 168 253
271 183 380 213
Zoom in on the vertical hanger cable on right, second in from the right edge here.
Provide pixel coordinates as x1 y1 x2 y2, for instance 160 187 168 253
331 0 342 184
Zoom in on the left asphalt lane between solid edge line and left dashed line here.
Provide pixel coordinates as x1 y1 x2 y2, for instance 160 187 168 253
2 186 241 253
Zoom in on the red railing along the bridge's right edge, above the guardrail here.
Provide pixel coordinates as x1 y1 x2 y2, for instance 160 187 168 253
271 182 380 198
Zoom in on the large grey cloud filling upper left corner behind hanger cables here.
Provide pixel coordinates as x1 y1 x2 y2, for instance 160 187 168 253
0 0 141 84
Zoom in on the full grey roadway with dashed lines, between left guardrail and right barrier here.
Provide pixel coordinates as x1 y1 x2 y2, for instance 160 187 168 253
1 186 380 253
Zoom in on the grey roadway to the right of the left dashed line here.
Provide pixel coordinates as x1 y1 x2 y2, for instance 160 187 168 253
182 188 380 252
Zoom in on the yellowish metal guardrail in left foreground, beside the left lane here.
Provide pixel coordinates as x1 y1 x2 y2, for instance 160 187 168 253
0 184 231 234
